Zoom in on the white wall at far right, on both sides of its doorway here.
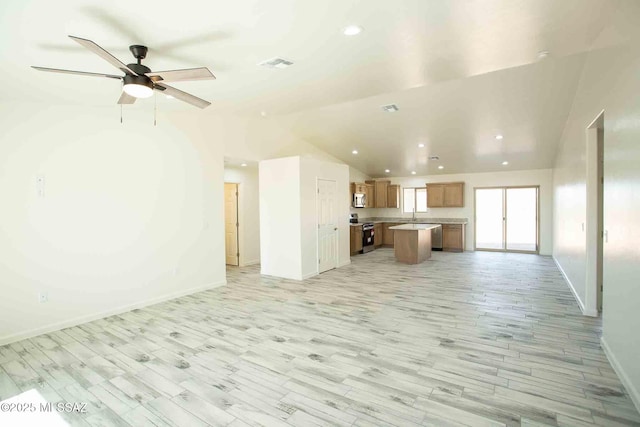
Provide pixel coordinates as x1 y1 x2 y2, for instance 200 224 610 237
553 40 640 409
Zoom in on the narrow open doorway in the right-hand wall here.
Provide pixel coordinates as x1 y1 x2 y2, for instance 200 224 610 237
584 111 607 316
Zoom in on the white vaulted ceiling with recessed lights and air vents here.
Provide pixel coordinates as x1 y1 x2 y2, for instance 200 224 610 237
0 0 640 176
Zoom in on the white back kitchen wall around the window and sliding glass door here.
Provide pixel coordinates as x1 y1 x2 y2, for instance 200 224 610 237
358 169 553 255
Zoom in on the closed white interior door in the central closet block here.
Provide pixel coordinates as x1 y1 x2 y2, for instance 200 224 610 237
317 179 338 273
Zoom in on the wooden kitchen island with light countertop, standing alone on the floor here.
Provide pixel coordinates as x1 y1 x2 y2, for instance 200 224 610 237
389 224 441 264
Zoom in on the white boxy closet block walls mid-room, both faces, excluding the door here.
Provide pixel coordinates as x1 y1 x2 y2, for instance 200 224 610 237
259 156 350 280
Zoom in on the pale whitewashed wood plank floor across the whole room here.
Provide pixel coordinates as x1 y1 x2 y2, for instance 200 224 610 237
0 249 640 427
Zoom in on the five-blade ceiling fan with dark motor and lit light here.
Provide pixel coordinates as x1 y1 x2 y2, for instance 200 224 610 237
32 36 216 108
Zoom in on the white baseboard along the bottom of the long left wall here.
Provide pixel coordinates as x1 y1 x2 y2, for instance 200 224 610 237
0 280 227 346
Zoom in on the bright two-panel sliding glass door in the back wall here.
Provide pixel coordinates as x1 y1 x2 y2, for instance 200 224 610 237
474 186 540 254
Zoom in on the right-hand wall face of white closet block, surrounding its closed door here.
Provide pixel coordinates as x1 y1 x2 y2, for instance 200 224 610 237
300 158 351 278
